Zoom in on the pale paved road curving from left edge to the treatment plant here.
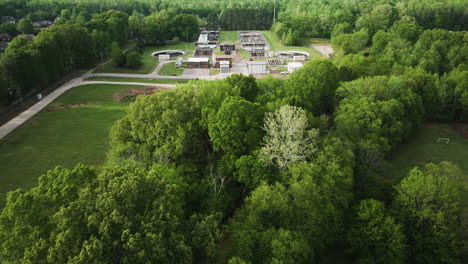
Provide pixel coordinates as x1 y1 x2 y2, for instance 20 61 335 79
0 58 247 140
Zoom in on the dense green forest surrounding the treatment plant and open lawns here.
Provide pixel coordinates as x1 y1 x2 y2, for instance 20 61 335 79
0 0 468 264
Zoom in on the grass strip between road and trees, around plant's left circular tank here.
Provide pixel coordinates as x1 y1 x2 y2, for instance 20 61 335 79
94 41 195 74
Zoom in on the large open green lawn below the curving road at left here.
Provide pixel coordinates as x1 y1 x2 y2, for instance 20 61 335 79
0 84 134 207
